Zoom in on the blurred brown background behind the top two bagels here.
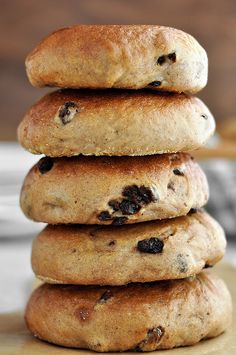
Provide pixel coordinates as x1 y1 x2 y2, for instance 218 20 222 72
0 0 236 140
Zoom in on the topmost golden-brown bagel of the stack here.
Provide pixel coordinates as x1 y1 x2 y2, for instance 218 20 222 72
26 25 208 93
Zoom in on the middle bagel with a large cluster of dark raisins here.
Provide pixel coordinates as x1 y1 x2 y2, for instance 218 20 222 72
21 153 208 225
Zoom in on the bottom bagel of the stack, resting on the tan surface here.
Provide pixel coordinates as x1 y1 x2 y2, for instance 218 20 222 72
25 270 232 352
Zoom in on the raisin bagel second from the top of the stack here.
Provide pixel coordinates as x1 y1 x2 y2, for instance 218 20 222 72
18 90 215 157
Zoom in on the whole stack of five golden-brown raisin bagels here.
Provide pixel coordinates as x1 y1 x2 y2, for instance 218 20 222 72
18 25 231 352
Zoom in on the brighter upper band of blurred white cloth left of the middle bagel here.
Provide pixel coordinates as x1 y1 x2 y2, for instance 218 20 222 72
0 143 42 240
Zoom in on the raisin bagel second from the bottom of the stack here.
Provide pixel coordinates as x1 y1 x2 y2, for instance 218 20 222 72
32 211 226 285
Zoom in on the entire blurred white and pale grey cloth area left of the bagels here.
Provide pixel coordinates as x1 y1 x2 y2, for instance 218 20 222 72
0 143 44 313
